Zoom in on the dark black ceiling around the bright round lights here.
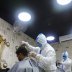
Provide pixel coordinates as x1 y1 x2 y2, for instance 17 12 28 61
0 0 72 41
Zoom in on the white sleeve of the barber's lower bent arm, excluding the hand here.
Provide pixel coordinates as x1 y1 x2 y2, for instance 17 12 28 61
36 51 55 69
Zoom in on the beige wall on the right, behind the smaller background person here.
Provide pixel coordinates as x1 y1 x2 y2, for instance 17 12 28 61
52 40 72 60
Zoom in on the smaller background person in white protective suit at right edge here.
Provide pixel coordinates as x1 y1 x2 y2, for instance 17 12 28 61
61 51 72 72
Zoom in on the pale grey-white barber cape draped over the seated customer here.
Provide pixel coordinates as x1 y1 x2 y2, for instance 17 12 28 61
8 57 39 72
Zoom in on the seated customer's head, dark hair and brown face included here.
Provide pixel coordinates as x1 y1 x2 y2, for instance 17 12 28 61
16 45 28 61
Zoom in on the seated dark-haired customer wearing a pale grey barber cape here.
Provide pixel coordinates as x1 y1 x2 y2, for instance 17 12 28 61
8 45 39 72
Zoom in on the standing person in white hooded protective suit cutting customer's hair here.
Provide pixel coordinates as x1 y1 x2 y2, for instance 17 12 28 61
22 33 57 72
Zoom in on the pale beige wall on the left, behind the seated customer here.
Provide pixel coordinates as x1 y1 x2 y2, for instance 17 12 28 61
0 18 35 67
